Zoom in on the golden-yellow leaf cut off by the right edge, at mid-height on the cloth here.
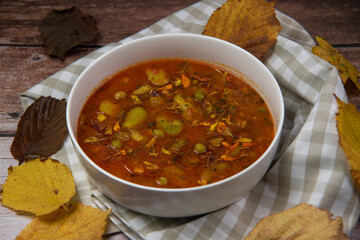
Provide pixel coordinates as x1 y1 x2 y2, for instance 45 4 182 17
336 97 360 185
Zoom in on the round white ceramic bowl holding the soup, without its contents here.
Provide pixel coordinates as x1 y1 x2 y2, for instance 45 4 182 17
66 33 284 217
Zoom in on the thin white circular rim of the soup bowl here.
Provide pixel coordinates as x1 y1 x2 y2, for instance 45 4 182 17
66 33 285 193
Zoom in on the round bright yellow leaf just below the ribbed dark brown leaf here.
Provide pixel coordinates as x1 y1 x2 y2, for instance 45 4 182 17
1 158 75 215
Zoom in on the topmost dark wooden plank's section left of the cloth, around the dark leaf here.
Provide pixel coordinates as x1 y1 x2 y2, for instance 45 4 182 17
0 0 198 45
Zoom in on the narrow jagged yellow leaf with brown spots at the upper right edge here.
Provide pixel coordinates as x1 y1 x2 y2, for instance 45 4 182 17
312 37 360 90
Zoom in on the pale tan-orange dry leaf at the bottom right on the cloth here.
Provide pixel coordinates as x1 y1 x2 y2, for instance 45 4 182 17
245 203 347 240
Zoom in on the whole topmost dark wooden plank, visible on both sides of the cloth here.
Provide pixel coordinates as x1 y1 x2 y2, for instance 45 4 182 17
0 0 360 45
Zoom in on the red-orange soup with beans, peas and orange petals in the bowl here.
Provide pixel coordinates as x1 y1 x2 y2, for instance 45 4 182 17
77 59 275 188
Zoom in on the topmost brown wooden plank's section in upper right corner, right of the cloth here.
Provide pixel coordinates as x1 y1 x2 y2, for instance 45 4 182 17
276 0 360 44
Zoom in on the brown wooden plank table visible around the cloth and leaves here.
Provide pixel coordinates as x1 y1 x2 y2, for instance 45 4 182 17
0 0 360 239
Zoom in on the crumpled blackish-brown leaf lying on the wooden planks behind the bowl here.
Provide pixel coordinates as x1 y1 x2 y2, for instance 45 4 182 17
40 7 97 59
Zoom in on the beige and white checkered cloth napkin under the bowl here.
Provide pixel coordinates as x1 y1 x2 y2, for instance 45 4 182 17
21 0 360 239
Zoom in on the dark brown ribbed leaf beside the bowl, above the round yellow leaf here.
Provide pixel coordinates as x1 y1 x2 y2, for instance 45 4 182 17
10 96 67 162
